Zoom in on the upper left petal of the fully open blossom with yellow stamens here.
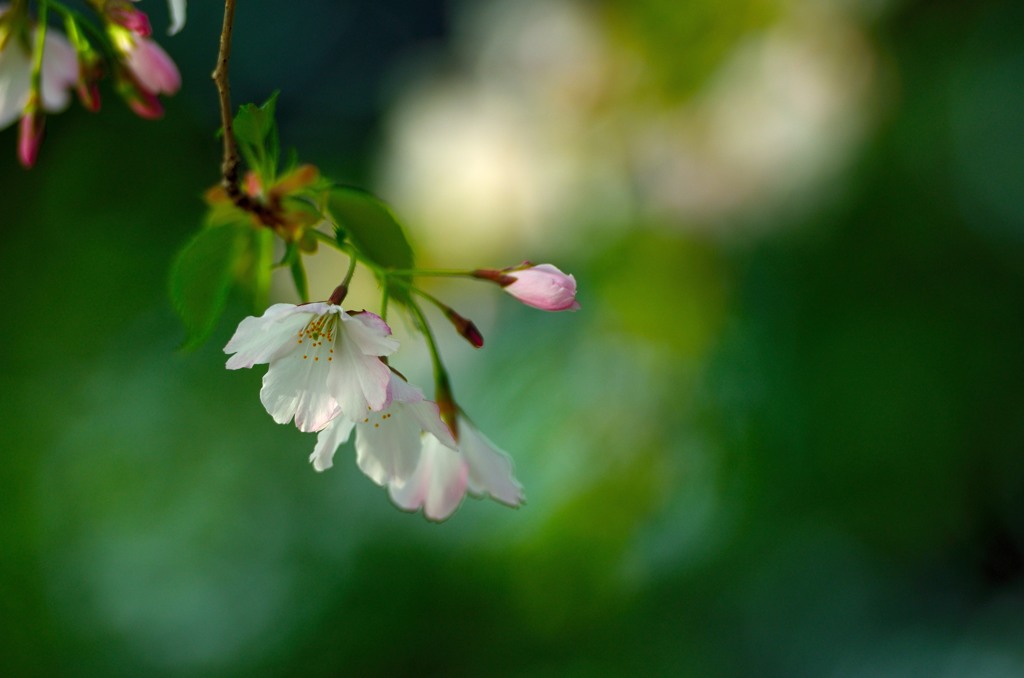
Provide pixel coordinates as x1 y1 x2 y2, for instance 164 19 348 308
224 304 313 370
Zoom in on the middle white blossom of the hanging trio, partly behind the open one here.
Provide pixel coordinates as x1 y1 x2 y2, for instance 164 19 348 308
309 377 457 485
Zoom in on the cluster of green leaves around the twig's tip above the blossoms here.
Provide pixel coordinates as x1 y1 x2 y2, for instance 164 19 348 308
169 92 415 349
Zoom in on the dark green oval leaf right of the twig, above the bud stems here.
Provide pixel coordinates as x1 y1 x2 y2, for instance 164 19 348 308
328 187 413 269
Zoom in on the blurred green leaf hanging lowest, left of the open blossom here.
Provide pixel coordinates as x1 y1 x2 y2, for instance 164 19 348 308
170 224 253 350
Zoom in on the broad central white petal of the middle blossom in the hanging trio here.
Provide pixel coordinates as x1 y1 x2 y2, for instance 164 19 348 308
355 403 420 485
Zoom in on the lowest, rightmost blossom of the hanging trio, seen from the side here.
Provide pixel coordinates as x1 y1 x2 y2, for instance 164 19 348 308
388 417 525 522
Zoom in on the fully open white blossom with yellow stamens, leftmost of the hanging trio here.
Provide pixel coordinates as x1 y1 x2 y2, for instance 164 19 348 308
224 302 398 431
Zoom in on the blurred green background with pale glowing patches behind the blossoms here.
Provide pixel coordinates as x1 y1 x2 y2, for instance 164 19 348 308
0 0 1024 676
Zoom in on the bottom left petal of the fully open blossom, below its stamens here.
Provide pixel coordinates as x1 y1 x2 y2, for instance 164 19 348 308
259 351 340 432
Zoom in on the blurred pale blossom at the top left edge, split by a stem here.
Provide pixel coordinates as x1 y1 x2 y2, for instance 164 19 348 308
0 19 78 129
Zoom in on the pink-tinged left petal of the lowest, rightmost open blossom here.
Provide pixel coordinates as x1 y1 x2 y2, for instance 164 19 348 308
388 435 468 521
